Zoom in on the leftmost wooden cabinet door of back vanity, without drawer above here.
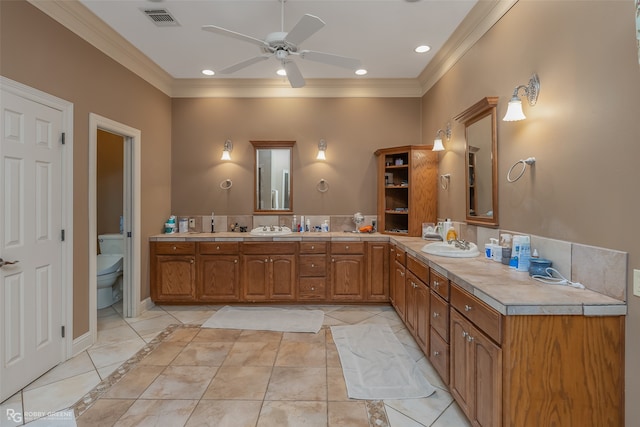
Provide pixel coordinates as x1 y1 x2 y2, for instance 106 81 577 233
151 255 196 302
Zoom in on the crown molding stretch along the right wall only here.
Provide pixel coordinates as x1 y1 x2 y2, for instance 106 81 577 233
418 0 518 95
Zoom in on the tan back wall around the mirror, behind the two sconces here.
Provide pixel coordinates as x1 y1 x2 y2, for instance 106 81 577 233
170 98 421 217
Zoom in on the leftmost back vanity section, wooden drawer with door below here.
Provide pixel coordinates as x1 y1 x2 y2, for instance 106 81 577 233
150 242 196 302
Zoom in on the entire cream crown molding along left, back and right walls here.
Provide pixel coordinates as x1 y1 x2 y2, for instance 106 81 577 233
28 0 518 98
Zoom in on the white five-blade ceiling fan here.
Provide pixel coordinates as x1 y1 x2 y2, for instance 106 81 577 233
202 0 360 88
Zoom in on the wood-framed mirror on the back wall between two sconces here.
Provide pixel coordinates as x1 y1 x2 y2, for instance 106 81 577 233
250 141 296 213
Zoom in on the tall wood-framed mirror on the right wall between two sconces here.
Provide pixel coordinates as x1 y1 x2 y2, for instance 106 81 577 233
455 96 498 226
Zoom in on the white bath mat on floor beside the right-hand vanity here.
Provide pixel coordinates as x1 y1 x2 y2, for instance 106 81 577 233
331 325 435 400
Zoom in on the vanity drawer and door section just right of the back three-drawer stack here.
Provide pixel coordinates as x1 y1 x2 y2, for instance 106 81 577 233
330 241 366 302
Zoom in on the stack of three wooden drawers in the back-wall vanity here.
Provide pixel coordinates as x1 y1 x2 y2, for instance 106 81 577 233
298 242 328 301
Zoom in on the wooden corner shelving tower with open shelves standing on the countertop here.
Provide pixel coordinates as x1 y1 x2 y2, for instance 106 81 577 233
375 145 438 237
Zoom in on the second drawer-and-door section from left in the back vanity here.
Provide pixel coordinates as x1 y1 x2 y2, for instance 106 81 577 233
196 242 240 302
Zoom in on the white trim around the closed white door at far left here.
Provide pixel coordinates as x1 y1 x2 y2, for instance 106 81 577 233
0 76 73 361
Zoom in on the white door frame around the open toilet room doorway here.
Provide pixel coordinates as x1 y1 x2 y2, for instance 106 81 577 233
89 113 142 342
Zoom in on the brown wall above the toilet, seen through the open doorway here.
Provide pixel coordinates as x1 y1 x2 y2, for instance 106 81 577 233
96 130 124 235
